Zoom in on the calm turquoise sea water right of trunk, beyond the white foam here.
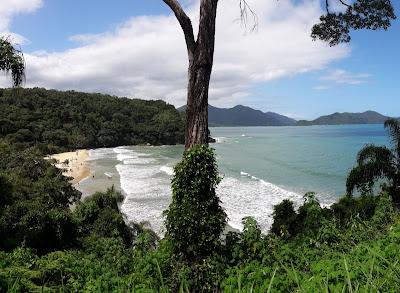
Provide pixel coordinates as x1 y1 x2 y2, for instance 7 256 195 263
212 125 389 198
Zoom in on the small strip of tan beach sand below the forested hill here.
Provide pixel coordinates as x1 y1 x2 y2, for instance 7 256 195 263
49 150 90 184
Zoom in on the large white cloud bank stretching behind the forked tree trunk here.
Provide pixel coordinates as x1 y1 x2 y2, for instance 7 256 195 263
1 0 350 106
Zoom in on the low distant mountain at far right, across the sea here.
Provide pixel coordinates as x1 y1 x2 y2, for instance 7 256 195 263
297 111 389 126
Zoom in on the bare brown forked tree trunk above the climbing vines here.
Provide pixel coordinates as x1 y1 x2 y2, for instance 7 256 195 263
163 0 218 150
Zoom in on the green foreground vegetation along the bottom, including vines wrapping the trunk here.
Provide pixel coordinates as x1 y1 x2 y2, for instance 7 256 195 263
0 142 400 292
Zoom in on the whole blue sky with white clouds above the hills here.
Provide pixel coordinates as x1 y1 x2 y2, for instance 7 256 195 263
0 0 400 119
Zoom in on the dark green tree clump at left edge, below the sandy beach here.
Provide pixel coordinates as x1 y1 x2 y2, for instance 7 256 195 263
0 145 80 253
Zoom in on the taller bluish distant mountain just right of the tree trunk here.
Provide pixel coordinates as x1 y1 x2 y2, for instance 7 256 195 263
178 105 297 126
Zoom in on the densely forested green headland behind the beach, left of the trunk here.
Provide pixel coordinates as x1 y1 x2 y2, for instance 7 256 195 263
0 88 184 152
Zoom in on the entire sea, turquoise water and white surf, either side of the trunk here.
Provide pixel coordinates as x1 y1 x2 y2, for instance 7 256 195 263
77 125 389 234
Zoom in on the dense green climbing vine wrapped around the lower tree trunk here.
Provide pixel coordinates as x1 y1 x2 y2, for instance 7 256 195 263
165 145 226 261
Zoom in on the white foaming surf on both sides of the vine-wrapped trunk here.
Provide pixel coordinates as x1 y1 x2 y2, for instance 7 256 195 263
112 148 302 235
